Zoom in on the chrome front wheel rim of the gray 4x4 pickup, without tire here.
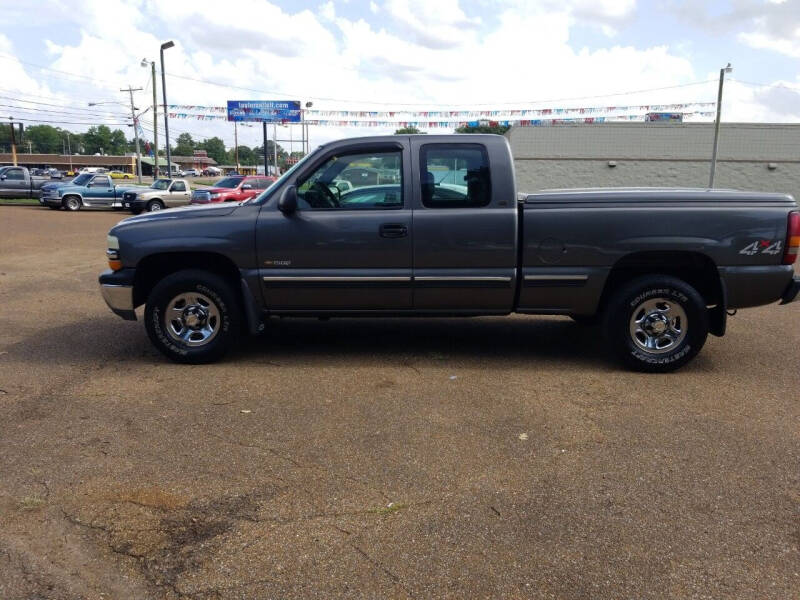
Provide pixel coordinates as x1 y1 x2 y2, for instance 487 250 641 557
164 292 221 347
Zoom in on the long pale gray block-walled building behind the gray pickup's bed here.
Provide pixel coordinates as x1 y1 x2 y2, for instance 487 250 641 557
506 123 800 198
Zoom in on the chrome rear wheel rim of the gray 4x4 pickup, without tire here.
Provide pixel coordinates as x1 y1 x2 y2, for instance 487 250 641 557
630 298 689 354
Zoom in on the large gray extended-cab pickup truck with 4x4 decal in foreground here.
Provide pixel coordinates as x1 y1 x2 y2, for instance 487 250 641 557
100 135 800 372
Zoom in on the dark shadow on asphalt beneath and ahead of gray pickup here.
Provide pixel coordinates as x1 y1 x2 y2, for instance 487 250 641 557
7 317 615 368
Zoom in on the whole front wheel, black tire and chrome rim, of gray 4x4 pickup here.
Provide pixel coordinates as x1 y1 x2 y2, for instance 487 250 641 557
144 269 241 364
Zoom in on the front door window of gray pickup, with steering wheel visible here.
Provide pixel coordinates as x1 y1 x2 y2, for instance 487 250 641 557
297 150 403 210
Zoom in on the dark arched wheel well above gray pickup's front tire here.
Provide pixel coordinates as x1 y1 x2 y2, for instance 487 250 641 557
133 252 242 306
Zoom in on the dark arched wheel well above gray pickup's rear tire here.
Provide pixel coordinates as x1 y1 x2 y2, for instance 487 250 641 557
598 251 723 310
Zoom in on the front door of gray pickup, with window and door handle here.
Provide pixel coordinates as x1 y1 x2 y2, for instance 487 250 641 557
257 144 412 312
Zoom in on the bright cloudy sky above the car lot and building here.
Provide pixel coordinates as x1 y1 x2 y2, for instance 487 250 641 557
0 0 800 150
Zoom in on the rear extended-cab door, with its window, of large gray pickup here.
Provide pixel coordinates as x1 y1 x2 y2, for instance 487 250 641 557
411 136 517 313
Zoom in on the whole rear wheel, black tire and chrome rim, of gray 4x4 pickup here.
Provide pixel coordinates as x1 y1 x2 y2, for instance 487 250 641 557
603 275 708 373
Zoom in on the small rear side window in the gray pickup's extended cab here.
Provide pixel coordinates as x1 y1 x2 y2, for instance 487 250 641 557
420 144 492 208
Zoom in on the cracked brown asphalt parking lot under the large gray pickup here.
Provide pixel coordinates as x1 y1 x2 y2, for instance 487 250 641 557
0 207 800 600
